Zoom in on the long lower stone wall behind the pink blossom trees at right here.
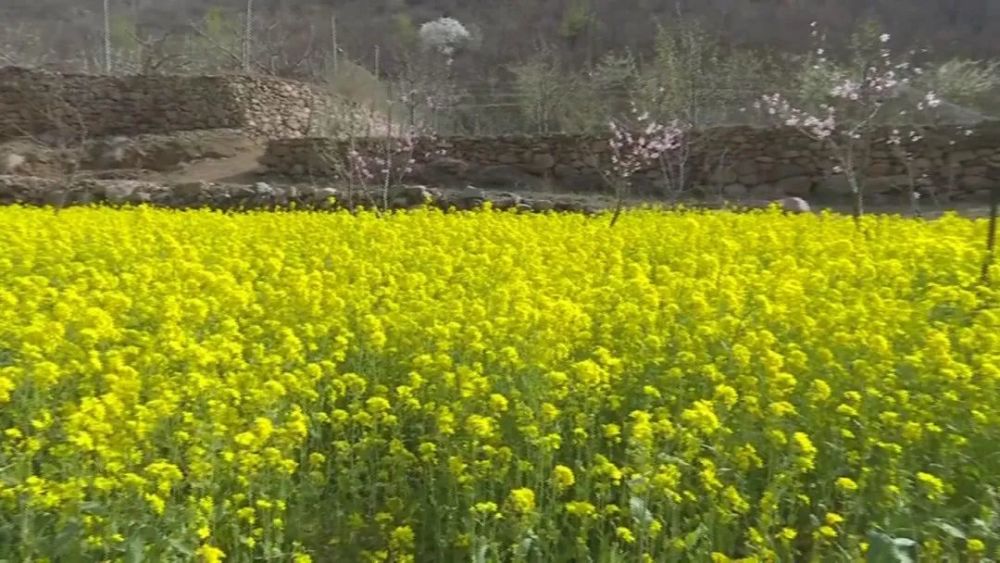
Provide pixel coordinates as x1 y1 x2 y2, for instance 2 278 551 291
261 122 1000 202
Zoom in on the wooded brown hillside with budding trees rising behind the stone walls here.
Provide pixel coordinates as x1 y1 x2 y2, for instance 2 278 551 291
0 0 1000 134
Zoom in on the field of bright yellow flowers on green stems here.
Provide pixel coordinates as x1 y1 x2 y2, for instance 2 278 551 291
0 207 1000 563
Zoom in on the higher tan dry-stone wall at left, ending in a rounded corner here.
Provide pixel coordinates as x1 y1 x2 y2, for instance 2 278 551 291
0 67 319 141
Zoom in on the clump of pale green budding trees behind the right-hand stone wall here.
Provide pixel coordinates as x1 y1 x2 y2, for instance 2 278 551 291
511 17 771 132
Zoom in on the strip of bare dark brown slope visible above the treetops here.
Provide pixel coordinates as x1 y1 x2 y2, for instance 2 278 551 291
0 0 1000 70
